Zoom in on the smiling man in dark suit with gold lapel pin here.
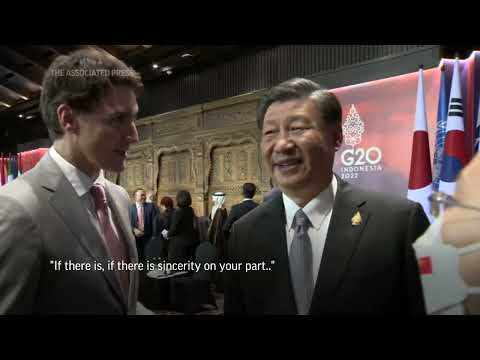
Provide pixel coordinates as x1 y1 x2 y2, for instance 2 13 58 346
225 79 428 315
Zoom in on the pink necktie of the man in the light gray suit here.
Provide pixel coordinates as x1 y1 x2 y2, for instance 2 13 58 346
90 184 129 294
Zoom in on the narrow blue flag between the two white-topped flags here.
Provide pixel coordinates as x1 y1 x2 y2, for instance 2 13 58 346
433 64 448 191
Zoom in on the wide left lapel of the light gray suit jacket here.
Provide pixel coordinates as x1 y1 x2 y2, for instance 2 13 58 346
39 155 125 310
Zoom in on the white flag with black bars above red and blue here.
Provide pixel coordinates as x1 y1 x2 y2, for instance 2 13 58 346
438 59 467 195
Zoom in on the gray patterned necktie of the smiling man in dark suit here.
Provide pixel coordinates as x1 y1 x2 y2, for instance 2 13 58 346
289 209 313 315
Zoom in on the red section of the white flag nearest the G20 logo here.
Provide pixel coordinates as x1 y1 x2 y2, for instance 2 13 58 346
408 131 432 190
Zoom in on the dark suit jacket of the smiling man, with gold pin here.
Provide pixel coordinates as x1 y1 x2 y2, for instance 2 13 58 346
225 178 429 315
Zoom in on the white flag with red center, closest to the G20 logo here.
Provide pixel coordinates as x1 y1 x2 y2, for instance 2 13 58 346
407 69 433 222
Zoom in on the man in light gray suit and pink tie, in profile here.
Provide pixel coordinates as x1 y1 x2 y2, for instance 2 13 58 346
0 50 151 314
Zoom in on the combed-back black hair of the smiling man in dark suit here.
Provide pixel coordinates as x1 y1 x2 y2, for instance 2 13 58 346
257 78 342 129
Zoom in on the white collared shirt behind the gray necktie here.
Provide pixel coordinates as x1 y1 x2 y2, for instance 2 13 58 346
282 176 338 284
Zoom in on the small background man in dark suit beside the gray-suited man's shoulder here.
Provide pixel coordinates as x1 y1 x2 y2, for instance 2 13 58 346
130 188 157 262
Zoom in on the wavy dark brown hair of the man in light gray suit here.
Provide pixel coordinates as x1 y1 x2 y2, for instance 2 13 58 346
40 49 143 141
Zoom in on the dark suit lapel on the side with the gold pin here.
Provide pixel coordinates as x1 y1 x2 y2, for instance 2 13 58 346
310 178 370 314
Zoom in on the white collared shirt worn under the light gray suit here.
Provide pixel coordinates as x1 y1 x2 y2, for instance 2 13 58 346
48 146 120 245
